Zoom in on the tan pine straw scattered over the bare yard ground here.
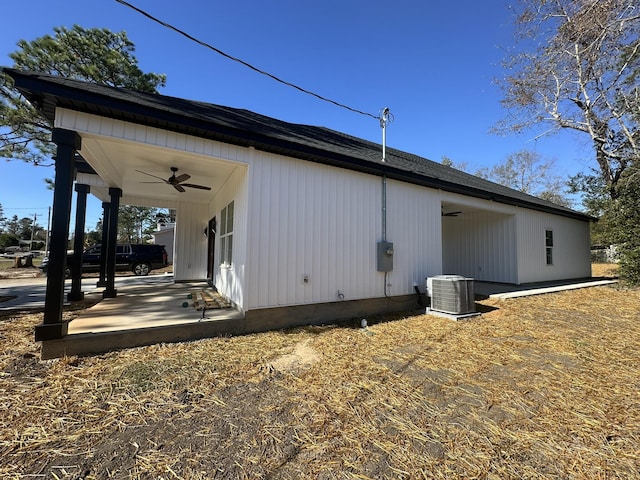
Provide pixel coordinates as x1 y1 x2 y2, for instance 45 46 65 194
0 266 640 480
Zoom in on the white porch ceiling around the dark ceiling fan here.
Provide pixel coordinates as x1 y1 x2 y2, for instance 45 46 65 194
80 135 239 207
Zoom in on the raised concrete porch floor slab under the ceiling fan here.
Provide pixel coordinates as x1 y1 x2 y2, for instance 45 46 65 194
41 275 245 359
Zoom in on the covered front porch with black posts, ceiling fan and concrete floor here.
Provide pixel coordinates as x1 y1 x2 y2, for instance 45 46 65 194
36 110 247 350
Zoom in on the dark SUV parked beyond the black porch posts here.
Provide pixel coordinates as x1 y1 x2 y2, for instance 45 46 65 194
40 243 168 277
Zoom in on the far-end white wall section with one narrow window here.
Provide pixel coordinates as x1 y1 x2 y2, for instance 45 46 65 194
517 209 591 283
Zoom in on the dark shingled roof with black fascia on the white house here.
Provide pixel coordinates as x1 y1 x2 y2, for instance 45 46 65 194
2 68 593 221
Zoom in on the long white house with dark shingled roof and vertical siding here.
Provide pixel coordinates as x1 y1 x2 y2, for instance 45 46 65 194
5 69 592 339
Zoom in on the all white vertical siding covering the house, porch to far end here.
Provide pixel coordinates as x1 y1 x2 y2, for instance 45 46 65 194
55 109 590 308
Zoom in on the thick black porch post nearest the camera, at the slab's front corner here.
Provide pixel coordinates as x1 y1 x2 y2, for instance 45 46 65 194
35 128 81 342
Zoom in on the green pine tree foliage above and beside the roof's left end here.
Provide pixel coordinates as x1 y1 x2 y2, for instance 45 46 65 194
0 25 166 165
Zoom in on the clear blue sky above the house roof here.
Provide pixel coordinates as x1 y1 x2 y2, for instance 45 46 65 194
0 0 593 227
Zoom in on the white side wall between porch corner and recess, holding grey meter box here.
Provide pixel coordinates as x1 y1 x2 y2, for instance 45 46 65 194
247 151 441 309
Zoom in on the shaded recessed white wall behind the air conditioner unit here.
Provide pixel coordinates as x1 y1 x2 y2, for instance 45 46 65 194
442 211 518 283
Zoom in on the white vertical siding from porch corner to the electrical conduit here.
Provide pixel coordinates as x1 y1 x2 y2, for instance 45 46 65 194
248 152 380 308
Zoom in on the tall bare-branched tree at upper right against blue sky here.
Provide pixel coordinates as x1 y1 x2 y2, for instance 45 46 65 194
498 0 640 198
